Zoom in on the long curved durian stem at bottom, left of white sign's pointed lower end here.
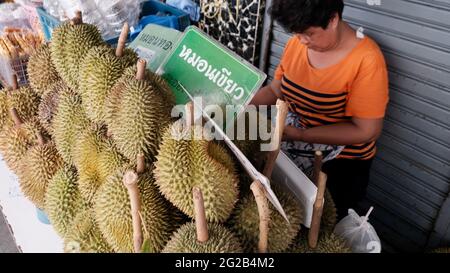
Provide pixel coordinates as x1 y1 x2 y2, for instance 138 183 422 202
250 180 270 253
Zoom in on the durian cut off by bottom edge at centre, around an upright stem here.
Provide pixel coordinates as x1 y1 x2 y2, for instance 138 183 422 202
162 222 242 253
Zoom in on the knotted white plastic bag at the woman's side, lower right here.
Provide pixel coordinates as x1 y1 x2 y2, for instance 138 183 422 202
334 207 381 253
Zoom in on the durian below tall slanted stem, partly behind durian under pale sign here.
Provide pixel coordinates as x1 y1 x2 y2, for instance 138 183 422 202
80 45 137 124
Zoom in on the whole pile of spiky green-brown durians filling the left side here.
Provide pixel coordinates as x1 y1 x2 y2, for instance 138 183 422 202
0 14 348 252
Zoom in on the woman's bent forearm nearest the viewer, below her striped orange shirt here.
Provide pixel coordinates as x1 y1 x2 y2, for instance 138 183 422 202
283 118 383 145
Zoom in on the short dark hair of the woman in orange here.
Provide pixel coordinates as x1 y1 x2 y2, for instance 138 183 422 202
270 0 344 33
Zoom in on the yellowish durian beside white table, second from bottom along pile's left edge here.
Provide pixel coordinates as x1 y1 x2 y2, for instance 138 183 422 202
44 165 87 237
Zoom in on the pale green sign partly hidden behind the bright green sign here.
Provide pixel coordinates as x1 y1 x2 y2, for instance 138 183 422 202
129 24 182 72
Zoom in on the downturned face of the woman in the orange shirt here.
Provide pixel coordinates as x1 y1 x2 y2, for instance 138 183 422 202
295 15 339 52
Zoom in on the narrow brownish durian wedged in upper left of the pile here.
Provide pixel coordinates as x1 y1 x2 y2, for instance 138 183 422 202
38 81 62 134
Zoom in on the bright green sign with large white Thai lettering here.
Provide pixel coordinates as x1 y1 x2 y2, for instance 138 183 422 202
157 26 266 106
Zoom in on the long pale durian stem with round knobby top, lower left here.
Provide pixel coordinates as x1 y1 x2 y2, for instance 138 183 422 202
123 171 143 253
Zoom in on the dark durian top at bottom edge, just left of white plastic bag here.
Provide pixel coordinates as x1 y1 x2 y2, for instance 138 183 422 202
288 232 352 253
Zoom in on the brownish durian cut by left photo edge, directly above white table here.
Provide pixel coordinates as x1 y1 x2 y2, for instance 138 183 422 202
0 118 45 173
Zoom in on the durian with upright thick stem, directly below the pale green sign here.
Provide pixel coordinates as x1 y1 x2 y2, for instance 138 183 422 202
108 61 170 161
